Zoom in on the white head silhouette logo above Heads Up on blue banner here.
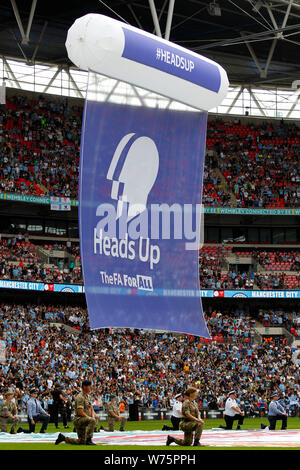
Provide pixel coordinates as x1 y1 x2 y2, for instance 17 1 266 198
107 133 159 220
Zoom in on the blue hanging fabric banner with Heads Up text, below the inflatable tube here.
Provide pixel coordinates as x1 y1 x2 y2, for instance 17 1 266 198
79 93 209 337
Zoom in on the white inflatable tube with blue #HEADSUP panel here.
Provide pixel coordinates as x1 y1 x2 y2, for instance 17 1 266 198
66 14 229 111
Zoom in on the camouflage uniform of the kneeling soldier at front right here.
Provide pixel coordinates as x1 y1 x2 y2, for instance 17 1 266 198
173 400 203 446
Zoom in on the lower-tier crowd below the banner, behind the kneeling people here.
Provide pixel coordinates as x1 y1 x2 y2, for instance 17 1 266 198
0 303 300 412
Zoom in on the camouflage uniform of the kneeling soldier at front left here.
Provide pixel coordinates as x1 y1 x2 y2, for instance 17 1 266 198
65 392 97 444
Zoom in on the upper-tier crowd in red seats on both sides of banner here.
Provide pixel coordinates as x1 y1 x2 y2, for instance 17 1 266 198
0 95 300 208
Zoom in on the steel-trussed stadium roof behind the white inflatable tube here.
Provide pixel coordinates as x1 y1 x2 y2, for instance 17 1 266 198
0 0 300 118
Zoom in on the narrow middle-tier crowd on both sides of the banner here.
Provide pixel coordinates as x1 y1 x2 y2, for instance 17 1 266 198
0 239 300 290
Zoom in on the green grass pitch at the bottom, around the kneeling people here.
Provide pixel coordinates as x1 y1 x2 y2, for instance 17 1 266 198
0 417 300 452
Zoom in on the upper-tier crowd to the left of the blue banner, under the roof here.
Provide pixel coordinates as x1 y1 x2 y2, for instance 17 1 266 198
0 95 82 198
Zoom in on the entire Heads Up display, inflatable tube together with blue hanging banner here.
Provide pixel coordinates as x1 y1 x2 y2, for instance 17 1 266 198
66 13 228 337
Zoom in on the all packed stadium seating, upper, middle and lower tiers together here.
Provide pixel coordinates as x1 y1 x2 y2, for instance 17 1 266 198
0 90 300 420
